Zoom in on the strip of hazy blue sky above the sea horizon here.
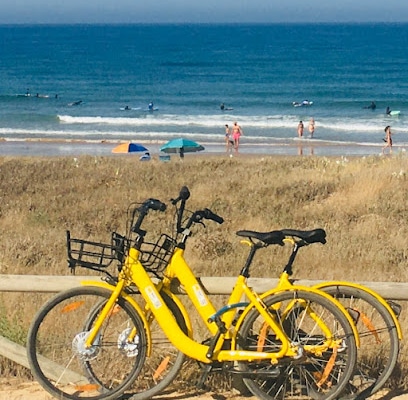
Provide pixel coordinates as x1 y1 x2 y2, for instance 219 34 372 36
0 0 408 24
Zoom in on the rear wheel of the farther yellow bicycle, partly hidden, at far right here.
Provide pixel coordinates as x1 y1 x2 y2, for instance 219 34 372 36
320 284 400 398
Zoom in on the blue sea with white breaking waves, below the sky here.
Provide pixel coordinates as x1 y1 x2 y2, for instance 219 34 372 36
0 23 408 156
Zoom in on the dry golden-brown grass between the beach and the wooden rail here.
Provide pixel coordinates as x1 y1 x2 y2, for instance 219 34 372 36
0 152 408 386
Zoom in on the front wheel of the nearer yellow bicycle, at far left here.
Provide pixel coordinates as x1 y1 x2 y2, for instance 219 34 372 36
27 286 147 400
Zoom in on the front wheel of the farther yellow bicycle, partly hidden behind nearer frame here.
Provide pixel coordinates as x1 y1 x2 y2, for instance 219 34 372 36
85 291 187 400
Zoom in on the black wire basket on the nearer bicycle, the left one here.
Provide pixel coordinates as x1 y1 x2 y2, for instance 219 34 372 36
67 231 128 271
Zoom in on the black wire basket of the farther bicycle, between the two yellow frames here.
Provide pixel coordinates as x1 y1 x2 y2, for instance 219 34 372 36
140 233 175 273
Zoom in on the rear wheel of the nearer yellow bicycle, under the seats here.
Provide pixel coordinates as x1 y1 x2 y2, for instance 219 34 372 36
238 290 357 400
